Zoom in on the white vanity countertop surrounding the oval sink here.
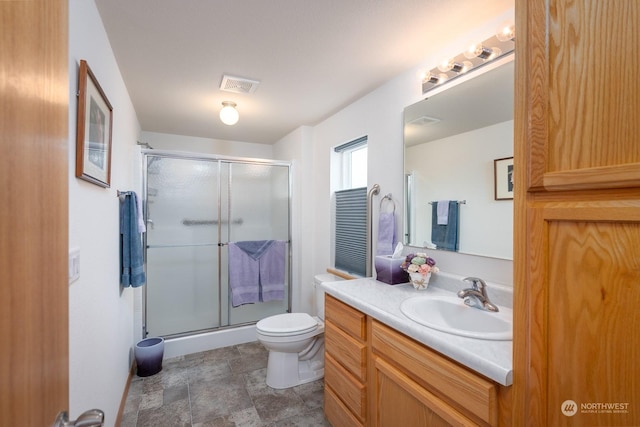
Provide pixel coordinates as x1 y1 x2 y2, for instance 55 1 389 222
321 278 513 386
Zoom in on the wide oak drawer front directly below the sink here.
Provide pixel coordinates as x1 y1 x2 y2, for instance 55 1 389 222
371 321 498 426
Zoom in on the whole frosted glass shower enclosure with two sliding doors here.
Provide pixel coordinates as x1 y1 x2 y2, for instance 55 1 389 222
143 150 291 338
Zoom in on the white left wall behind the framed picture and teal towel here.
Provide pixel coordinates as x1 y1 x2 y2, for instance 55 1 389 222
69 0 140 425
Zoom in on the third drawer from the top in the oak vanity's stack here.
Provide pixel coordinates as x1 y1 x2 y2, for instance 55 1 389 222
324 354 367 421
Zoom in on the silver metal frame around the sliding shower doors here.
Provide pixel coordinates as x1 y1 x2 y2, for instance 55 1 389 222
141 148 292 339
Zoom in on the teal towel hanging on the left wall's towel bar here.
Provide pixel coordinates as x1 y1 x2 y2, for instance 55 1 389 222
119 191 147 288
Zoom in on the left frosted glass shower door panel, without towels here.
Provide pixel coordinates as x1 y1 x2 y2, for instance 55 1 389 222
146 156 220 336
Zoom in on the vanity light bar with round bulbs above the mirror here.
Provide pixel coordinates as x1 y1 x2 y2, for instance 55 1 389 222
421 22 515 95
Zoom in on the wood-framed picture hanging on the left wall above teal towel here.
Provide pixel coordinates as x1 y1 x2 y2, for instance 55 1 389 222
76 59 113 187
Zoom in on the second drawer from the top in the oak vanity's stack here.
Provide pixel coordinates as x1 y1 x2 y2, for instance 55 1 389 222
324 319 367 382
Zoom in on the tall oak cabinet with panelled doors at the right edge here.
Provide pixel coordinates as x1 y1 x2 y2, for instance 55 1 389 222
512 0 640 426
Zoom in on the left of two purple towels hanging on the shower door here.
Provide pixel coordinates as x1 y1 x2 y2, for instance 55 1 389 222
229 243 260 307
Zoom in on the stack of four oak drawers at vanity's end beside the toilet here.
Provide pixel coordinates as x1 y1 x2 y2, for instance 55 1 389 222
324 295 368 427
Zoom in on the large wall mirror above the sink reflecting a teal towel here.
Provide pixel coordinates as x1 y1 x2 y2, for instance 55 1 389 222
404 55 514 259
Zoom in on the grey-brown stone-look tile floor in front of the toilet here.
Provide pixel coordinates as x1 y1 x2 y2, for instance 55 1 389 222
121 342 330 427
